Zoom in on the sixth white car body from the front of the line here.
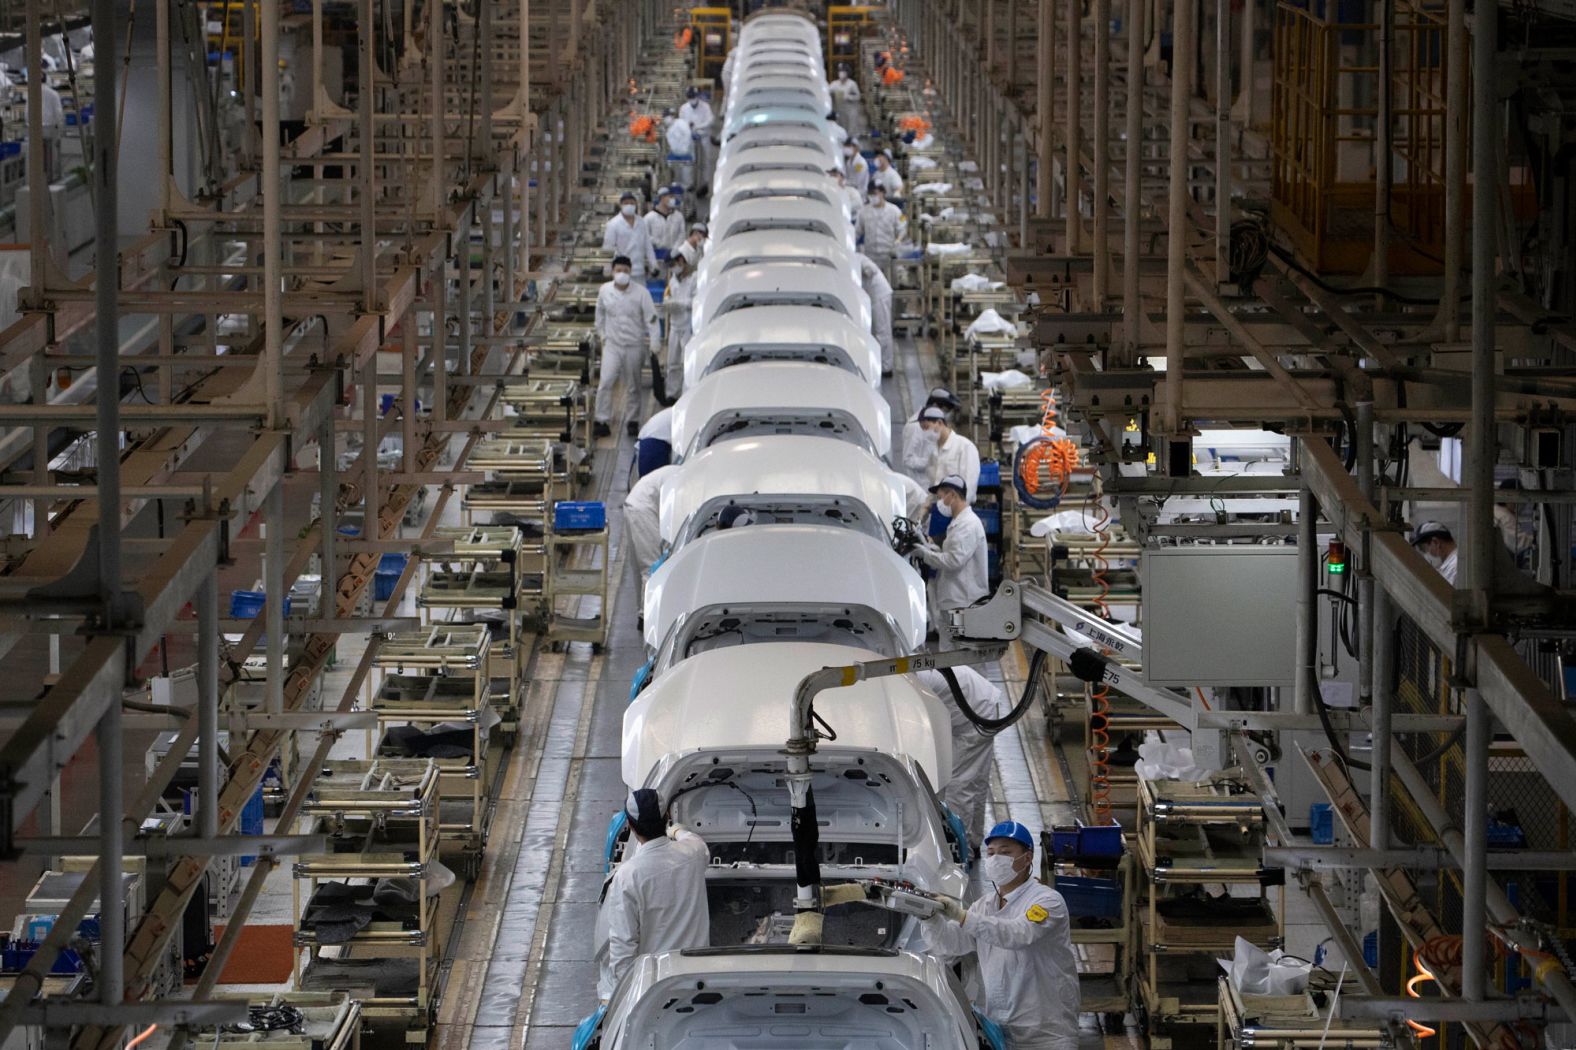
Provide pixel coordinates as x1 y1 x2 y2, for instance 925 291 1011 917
684 306 881 389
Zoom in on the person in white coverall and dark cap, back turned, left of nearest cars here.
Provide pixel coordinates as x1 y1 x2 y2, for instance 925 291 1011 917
597 788 711 1003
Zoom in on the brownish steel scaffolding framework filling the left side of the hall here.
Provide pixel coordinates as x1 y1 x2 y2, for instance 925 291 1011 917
0 0 659 1047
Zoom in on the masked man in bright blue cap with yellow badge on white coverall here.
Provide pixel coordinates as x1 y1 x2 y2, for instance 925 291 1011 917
925 820 1078 1050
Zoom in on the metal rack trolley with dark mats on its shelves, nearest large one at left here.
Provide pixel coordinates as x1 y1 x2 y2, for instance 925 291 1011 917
292 758 441 1042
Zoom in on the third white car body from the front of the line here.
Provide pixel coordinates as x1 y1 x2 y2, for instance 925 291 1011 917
645 525 927 649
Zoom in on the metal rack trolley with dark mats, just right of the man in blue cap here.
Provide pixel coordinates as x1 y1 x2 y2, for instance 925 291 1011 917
1135 773 1286 1050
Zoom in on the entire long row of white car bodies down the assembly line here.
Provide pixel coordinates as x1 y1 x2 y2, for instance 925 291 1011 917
575 11 1001 1050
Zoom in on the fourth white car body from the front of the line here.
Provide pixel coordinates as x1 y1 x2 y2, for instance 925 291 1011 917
657 434 908 550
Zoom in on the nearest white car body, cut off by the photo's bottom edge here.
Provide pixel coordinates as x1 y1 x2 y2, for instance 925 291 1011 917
592 944 1004 1050
